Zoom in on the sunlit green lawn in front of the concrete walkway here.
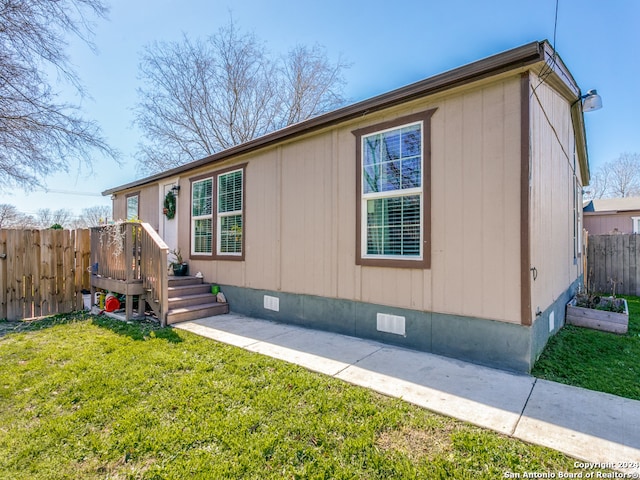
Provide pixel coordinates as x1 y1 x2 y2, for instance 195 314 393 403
0 314 576 480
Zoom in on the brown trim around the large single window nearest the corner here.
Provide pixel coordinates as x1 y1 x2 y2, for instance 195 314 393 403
351 108 437 269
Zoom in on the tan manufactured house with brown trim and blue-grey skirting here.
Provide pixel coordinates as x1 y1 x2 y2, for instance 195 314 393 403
104 41 589 372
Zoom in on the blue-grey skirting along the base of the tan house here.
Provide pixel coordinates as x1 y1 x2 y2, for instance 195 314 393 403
221 281 578 373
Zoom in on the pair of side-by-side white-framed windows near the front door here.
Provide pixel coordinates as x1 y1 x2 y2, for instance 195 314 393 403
191 166 244 259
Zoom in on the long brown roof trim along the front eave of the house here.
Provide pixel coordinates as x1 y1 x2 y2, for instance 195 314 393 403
102 40 562 195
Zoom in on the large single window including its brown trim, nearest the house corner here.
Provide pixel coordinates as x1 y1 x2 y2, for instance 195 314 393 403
354 110 434 268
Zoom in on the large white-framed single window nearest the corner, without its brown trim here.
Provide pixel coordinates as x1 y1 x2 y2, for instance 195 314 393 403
360 122 424 260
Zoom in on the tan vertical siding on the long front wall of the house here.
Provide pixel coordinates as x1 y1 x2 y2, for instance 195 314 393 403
152 76 520 322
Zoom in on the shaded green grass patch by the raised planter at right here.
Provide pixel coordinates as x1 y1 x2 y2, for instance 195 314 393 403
532 297 640 400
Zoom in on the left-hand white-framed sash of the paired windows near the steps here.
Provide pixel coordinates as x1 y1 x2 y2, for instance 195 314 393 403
191 178 213 255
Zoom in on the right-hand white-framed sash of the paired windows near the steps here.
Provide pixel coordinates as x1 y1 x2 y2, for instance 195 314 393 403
217 169 243 255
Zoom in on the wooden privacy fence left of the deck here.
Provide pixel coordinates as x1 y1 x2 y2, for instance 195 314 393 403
0 229 91 320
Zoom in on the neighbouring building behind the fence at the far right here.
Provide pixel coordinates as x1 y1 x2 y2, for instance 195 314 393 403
583 197 640 235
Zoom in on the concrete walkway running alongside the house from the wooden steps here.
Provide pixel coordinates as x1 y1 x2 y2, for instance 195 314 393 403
174 314 640 475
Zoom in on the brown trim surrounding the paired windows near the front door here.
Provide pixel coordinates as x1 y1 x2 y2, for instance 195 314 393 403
189 163 247 262
